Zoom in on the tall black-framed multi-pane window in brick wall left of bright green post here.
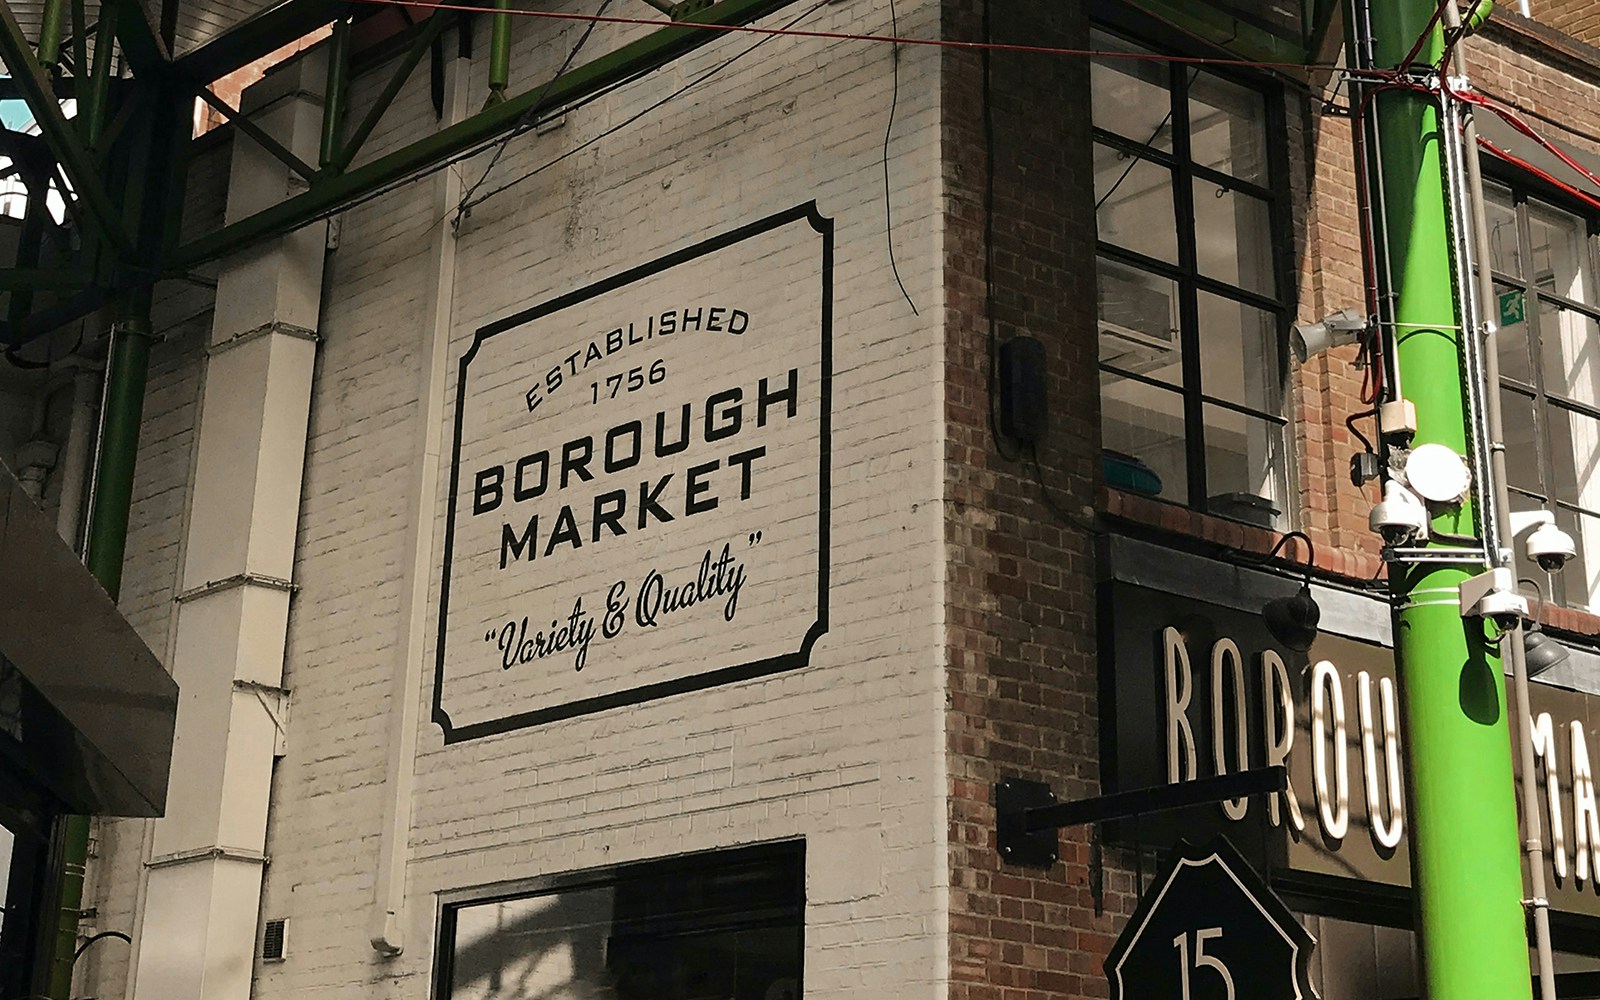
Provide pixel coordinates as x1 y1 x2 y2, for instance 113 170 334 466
1091 30 1291 528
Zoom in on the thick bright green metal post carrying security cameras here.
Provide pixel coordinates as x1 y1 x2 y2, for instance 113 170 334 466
1350 0 1530 1000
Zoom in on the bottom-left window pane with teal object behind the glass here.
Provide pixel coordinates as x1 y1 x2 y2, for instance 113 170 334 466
1101 371 1189 504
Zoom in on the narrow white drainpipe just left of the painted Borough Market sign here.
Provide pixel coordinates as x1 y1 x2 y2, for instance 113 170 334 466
368 44 470 957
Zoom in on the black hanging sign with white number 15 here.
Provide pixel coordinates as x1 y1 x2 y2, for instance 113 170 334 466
1106 837 1317 1000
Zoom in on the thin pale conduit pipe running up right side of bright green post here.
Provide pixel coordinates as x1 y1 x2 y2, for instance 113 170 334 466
1443 3 1555 1000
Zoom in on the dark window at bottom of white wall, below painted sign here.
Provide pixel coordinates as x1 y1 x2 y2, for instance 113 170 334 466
434 842 805 1000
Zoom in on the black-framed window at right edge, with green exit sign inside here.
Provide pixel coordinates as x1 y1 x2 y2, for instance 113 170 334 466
1485 184 1600 611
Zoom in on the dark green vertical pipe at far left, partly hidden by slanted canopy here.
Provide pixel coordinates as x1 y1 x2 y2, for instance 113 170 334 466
45 288 150 1000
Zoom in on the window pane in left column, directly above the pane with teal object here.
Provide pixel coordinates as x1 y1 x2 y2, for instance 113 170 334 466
1098 258 1184 386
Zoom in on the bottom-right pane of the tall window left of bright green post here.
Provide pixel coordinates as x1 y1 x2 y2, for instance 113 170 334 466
1205 405 1288 528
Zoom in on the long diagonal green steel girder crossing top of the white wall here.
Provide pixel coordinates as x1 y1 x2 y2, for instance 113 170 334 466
170 0 812 270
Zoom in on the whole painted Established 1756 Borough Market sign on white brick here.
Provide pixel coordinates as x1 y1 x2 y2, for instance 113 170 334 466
434 205 832 742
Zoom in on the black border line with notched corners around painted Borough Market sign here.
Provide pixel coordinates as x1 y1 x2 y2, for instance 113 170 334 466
434 202 834 744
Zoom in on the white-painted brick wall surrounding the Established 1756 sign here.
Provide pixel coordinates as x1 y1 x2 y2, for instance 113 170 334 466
87 0 947 1000
